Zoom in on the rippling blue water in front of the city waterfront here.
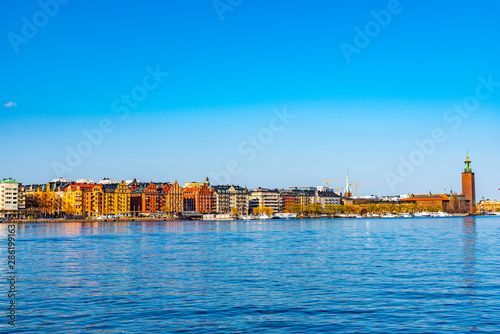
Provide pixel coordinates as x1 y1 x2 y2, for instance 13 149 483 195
0 217 500 333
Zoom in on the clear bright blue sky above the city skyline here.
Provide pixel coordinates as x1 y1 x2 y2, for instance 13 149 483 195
0 0 500 198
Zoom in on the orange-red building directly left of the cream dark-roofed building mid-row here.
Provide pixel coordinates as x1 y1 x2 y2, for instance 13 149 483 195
182 177 212 213
